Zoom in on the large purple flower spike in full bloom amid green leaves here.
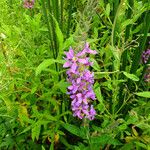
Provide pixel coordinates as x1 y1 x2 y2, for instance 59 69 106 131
63 43 97 120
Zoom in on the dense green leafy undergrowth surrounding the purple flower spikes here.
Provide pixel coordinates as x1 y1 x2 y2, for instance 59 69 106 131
0 0 150 150
